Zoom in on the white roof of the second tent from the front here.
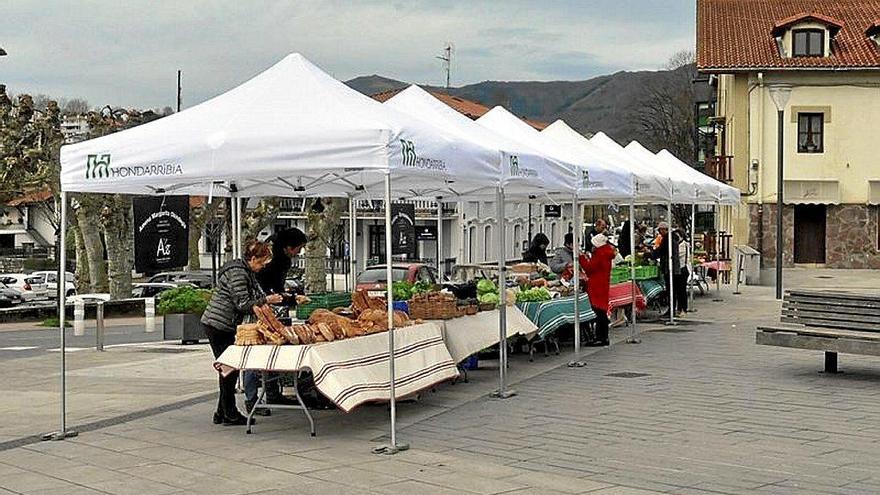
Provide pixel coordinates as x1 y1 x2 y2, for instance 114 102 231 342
385 85 571 199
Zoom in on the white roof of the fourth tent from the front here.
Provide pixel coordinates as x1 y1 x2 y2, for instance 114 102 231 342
541 120 670 201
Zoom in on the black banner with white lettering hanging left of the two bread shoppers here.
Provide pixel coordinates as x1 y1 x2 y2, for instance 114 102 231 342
132 196 189 273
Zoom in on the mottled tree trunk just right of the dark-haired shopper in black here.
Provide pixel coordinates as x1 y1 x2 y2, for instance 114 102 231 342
305 198 348 292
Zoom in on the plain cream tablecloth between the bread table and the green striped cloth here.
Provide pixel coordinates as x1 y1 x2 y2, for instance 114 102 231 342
437 306 538 363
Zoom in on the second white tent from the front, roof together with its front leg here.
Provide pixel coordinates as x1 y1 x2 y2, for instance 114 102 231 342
385 85 578 397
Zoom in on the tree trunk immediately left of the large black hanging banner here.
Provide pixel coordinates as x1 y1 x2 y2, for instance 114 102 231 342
101 195 134 299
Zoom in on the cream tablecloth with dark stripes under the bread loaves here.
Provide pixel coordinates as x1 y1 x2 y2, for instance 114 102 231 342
214 322 458 412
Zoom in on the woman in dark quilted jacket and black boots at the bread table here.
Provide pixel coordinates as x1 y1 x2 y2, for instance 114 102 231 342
201 241 283 425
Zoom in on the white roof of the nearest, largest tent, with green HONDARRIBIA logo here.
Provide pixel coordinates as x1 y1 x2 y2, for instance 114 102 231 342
61 53 499 201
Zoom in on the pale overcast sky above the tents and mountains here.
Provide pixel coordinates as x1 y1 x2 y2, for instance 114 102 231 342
0 0 695 108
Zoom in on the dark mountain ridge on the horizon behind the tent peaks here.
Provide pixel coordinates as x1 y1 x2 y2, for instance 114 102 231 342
346 65 694 151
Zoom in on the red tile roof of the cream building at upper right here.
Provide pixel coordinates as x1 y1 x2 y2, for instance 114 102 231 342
697 0 880 72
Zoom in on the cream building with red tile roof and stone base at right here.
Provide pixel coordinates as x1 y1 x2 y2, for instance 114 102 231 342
697 0 880 269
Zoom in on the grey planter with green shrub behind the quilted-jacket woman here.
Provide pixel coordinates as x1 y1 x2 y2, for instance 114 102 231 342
156 287 211 344
